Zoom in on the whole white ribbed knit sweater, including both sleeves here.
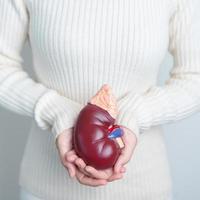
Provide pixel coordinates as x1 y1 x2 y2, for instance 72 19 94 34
0 0 200 200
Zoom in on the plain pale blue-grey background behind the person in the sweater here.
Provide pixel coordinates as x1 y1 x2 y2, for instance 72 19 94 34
0 39 200 200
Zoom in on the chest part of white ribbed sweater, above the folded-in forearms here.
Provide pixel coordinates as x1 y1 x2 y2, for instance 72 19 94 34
25 0 174 103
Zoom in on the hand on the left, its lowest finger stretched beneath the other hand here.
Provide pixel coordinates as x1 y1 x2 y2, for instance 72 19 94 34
56 127 107 187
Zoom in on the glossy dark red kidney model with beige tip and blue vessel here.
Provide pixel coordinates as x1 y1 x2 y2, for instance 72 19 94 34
73 84 124 169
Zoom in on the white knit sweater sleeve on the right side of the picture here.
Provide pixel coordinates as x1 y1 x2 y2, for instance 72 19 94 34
116 0 200 136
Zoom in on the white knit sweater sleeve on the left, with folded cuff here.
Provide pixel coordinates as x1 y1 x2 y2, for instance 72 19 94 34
0 0 83 138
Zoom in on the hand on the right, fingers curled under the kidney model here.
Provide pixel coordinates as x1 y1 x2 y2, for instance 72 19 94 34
66 126 137 182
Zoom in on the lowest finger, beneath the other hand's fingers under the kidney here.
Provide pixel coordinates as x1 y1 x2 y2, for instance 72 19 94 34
76 171 107 187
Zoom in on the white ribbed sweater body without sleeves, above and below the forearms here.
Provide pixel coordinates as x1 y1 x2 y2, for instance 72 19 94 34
20 0 174 200
